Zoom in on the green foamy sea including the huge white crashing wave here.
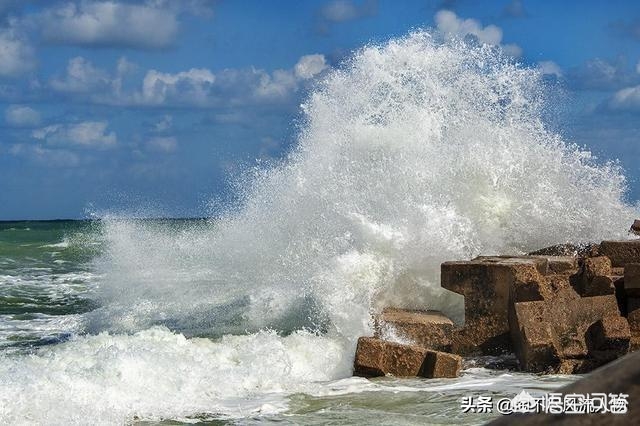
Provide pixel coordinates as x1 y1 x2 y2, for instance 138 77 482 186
0 31 638 424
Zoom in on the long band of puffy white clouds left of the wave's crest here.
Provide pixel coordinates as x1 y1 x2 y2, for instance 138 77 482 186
49 54 328 108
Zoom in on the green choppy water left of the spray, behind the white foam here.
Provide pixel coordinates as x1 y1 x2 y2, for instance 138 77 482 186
0 221 100 350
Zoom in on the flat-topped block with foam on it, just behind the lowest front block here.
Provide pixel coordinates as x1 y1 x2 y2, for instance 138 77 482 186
376 308 454 352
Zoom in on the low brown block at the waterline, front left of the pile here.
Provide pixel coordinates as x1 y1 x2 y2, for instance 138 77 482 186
354 337 462 378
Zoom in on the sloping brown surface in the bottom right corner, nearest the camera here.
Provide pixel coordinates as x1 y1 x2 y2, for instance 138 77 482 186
489 352 640 426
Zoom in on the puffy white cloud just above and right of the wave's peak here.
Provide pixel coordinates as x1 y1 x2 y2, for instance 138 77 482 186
435 10 522 57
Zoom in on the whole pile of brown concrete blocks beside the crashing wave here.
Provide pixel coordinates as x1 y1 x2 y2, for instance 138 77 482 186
355 226 640 377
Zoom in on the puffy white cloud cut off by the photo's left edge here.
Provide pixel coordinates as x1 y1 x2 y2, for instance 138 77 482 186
0 24 36 77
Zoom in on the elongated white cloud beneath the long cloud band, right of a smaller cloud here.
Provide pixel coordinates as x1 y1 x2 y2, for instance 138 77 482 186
32 121 118 148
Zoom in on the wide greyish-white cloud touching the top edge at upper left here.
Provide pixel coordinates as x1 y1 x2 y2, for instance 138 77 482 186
37 1 178 49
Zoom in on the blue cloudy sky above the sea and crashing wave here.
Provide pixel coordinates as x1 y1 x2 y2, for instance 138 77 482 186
0 0 640 220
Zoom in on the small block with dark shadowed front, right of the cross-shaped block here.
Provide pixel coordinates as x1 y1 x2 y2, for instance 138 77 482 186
587 315 631 362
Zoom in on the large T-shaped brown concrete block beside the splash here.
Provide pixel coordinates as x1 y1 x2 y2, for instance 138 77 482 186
441 257 548 355
